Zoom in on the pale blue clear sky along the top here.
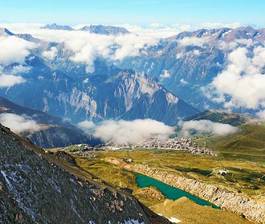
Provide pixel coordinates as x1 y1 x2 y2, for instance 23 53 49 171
0 0 265 26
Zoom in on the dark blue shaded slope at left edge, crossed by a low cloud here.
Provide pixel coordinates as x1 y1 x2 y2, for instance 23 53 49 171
0 97 99 147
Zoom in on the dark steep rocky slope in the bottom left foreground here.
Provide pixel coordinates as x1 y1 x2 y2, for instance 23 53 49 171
0 125 170 224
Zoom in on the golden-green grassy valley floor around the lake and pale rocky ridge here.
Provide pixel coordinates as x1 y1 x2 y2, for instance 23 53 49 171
54 147 265 224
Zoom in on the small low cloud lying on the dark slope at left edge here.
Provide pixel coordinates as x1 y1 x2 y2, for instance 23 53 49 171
0 113 48 134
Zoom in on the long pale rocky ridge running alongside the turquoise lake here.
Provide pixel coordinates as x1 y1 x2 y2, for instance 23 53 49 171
107 159 265 224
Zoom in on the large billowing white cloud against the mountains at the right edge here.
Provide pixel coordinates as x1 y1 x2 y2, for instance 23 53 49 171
208 47 265 109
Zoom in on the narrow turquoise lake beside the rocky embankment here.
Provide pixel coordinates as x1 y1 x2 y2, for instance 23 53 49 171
135 173 219 208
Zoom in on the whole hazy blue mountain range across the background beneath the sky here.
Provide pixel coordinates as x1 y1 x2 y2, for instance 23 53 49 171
0 24 265 125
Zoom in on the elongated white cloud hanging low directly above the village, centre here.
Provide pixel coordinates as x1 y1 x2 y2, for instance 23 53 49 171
94 119 174 144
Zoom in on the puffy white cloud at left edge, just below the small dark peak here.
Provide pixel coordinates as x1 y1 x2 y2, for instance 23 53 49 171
0 36 35 65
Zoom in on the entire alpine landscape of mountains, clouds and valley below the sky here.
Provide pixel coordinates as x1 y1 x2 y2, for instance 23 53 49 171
0 20 265 224
